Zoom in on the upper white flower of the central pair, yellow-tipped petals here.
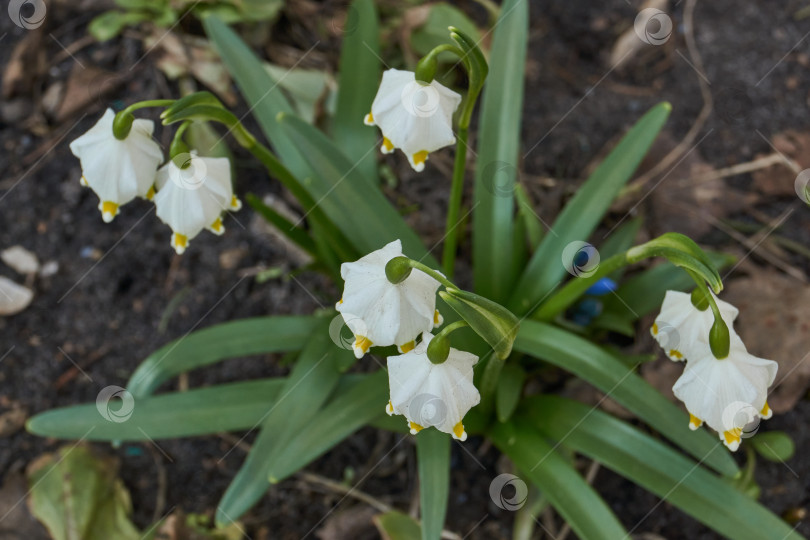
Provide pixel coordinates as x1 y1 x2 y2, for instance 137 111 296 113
335 240 443 358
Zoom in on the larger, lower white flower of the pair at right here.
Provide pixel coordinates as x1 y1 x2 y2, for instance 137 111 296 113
672 338 778 451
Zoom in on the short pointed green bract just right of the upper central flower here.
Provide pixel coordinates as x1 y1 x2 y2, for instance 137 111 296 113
439 288 520 360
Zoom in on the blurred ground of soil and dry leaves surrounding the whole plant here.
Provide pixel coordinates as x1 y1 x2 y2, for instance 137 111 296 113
0 0 810 540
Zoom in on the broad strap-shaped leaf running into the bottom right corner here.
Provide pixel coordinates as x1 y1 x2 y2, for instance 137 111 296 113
523 396 802 540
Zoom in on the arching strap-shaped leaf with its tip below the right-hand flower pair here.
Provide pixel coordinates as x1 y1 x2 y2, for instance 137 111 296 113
514 320 738 476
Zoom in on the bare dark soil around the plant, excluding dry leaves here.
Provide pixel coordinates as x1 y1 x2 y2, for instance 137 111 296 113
0 0 810 539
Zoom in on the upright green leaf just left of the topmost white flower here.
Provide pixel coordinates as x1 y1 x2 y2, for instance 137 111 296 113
332 0 380 184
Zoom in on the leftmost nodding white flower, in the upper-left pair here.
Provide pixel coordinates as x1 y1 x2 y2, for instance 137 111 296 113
70 109 163 223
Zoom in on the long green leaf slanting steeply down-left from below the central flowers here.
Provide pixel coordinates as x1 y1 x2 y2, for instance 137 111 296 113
216 321 354 525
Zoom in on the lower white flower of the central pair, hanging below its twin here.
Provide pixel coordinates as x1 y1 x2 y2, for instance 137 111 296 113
385 332 481 441
